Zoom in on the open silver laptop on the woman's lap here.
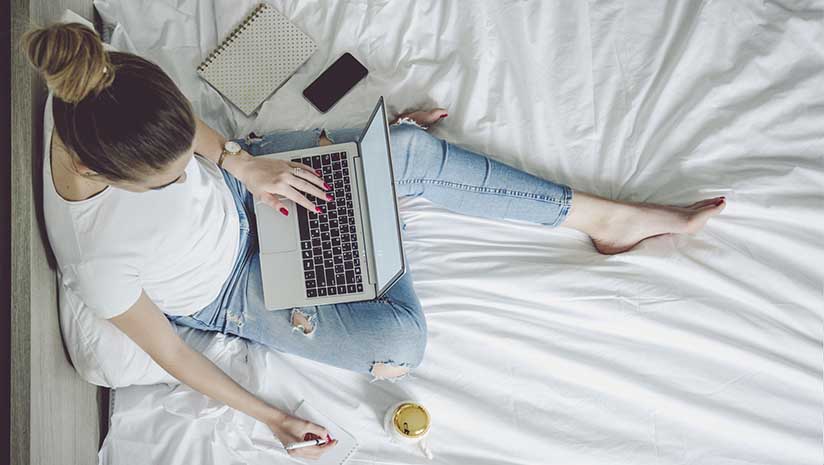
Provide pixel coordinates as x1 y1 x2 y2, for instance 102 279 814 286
255 97 406 310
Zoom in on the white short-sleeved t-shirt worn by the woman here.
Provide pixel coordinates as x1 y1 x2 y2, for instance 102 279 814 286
43 95 240 318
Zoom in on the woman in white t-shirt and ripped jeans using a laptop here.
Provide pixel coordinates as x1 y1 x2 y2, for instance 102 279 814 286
23 24 724 458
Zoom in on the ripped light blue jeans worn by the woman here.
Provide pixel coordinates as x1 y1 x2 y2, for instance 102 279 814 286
164 123 572 373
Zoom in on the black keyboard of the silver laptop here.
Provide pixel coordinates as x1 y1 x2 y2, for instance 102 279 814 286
292 152 363 298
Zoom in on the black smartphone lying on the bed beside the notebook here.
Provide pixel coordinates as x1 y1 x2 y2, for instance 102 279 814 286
303 53 369 113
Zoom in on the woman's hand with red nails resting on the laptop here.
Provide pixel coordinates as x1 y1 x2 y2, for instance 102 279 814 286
237 152 332 215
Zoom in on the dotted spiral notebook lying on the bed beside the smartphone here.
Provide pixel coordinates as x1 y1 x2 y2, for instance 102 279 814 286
197 3 318 116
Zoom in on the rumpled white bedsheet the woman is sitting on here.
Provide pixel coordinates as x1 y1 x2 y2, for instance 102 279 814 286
95 0 824 465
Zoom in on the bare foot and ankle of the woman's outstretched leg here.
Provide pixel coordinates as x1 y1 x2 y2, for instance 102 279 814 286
563 192 726 255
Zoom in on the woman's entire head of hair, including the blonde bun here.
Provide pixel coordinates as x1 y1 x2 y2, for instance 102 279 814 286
20 23 195 182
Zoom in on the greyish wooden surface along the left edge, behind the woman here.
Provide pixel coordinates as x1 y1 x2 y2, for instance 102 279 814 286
11 0 106 465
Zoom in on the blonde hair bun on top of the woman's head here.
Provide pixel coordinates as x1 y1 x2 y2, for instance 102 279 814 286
22 23 114 103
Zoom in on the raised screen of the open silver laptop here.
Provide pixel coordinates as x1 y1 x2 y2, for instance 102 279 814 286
360 98 405 295
